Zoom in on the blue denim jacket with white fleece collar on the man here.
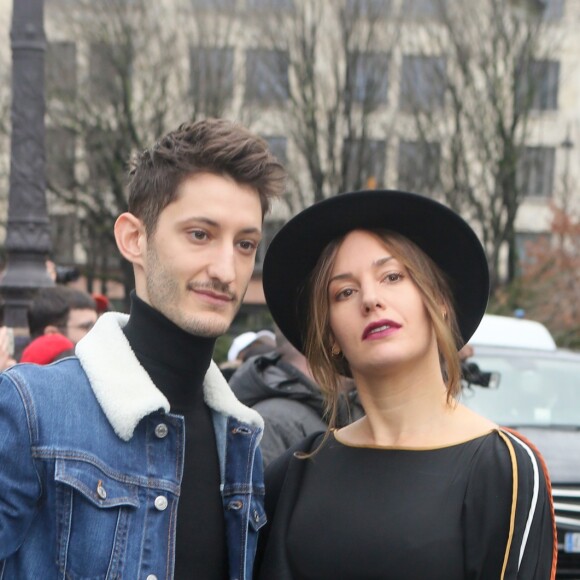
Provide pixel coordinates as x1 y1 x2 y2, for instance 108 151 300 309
0 313 266 580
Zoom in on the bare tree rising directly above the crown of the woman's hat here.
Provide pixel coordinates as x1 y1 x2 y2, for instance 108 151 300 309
246 0 398 212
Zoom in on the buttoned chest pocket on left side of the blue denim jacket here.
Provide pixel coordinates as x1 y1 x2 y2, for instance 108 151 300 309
55 458 139 580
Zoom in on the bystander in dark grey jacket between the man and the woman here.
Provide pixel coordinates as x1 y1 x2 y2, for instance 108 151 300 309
229 328 362 466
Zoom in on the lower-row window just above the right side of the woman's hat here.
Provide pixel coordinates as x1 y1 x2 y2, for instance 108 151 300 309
397 141 441 194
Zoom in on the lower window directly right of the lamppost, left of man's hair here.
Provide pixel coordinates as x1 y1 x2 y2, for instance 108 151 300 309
45 127 75 189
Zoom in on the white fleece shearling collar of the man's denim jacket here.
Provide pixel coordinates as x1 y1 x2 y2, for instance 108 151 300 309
75 312 264 441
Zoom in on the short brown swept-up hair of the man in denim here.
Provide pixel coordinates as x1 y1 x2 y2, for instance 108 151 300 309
128 119 286 236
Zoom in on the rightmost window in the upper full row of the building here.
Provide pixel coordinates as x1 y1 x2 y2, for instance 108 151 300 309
516 60 560 111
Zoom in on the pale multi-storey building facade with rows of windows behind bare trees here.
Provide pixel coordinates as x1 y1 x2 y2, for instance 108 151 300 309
0 0 580 309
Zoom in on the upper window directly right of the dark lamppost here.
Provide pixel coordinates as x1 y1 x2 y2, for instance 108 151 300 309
46 42 77 99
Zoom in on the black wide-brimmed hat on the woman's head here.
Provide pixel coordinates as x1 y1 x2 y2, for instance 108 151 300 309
262 190 489 352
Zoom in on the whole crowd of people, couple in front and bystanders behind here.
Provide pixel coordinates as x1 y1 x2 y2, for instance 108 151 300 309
0 119 557 580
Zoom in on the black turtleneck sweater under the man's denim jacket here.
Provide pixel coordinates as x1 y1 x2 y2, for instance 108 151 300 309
124 293 228 580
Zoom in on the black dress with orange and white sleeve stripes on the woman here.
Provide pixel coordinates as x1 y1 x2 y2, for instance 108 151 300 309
258 431 555 580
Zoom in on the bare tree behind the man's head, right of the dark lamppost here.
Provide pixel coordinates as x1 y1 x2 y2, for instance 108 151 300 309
47 0 244 306
